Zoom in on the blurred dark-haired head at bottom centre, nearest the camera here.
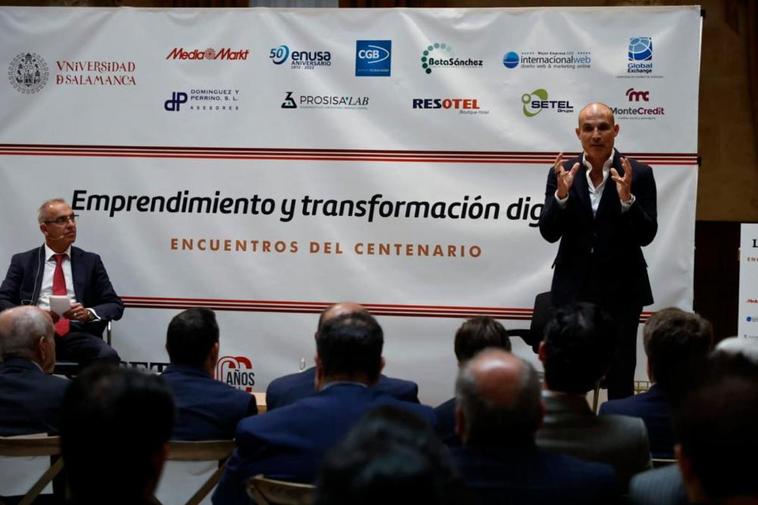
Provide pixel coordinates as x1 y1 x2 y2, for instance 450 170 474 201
315 406 468 505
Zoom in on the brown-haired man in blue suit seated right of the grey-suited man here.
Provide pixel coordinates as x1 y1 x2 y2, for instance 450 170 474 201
600 308 713 458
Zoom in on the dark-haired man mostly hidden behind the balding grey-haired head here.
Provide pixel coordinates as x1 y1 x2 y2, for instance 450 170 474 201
434 317 511 446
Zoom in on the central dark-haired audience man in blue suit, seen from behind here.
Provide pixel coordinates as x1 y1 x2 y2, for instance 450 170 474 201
213 312 434 505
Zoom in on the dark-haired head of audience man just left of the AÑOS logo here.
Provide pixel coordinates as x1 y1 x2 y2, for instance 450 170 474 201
166 308 219 367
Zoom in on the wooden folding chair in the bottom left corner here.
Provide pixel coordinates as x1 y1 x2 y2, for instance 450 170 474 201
0 435 63 505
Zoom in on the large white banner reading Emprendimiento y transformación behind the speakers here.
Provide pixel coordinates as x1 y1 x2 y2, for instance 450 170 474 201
0 7 701 403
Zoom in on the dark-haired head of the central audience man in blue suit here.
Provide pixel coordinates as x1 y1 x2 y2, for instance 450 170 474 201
316 312 384 380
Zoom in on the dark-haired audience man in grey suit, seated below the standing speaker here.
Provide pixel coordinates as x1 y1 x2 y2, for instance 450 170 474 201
537 303 651 486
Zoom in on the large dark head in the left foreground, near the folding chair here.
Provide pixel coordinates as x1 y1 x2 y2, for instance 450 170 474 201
60 365 175 505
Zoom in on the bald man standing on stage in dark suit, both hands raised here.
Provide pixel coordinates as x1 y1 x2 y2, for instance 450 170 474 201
539 103 658 399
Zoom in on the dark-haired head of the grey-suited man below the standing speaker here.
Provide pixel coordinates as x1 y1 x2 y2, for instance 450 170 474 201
544 302 616 394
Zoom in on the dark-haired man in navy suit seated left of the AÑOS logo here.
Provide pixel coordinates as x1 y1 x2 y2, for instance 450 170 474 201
163 308 258 440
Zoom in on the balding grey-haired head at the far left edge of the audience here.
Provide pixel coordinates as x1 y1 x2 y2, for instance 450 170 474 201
0 306 55 373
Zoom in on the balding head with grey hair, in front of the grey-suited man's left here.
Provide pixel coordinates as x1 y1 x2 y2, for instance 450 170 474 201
456 349 543 445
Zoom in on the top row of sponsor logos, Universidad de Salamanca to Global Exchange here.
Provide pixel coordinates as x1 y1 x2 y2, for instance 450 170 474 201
8 37 660 94
